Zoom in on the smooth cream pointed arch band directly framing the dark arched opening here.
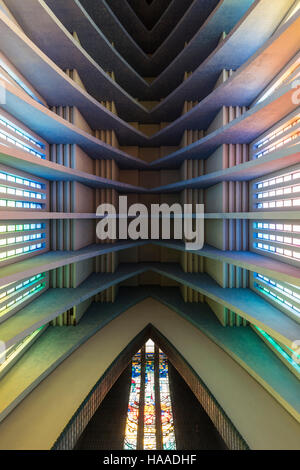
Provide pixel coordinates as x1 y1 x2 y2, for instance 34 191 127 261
0 299 300 449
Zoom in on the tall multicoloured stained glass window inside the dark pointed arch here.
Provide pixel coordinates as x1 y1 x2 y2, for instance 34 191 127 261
124 340 176 450
